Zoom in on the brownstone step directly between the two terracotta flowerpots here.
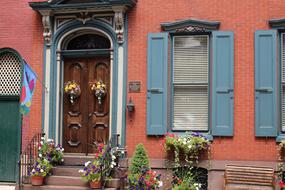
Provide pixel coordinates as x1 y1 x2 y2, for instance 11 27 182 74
45 175 88 187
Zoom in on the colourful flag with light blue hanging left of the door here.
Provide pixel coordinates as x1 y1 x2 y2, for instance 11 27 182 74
20 61 37 115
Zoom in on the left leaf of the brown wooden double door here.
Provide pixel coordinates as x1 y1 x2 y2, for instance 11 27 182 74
63 59 88 153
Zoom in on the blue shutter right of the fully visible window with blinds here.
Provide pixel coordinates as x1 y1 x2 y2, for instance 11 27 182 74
211 31 234 136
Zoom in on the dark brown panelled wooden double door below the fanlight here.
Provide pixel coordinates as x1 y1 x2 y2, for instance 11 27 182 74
63 57 110 153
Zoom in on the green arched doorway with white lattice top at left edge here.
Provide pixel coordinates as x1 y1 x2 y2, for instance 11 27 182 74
0 48 22 182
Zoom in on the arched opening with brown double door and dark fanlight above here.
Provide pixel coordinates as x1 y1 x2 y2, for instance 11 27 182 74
62 30 112 153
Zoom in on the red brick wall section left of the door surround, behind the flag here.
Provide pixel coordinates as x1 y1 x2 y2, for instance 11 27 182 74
0 0 43 146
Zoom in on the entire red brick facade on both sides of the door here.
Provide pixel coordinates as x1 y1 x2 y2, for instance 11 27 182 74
0 0 285 186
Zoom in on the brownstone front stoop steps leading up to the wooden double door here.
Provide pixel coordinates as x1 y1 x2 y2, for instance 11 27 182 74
16 154 122 190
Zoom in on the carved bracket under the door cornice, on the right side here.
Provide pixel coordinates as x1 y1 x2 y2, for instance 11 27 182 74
114 11 124 44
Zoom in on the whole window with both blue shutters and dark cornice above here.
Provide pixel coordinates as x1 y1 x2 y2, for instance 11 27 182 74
146 20 234 136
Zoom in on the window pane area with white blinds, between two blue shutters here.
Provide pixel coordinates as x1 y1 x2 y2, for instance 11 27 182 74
172 35 209 131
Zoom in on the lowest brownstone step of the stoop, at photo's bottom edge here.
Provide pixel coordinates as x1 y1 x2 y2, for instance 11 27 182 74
16 184 116 190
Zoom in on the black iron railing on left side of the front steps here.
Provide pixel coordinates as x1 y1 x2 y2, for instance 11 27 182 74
18 133 45 190
